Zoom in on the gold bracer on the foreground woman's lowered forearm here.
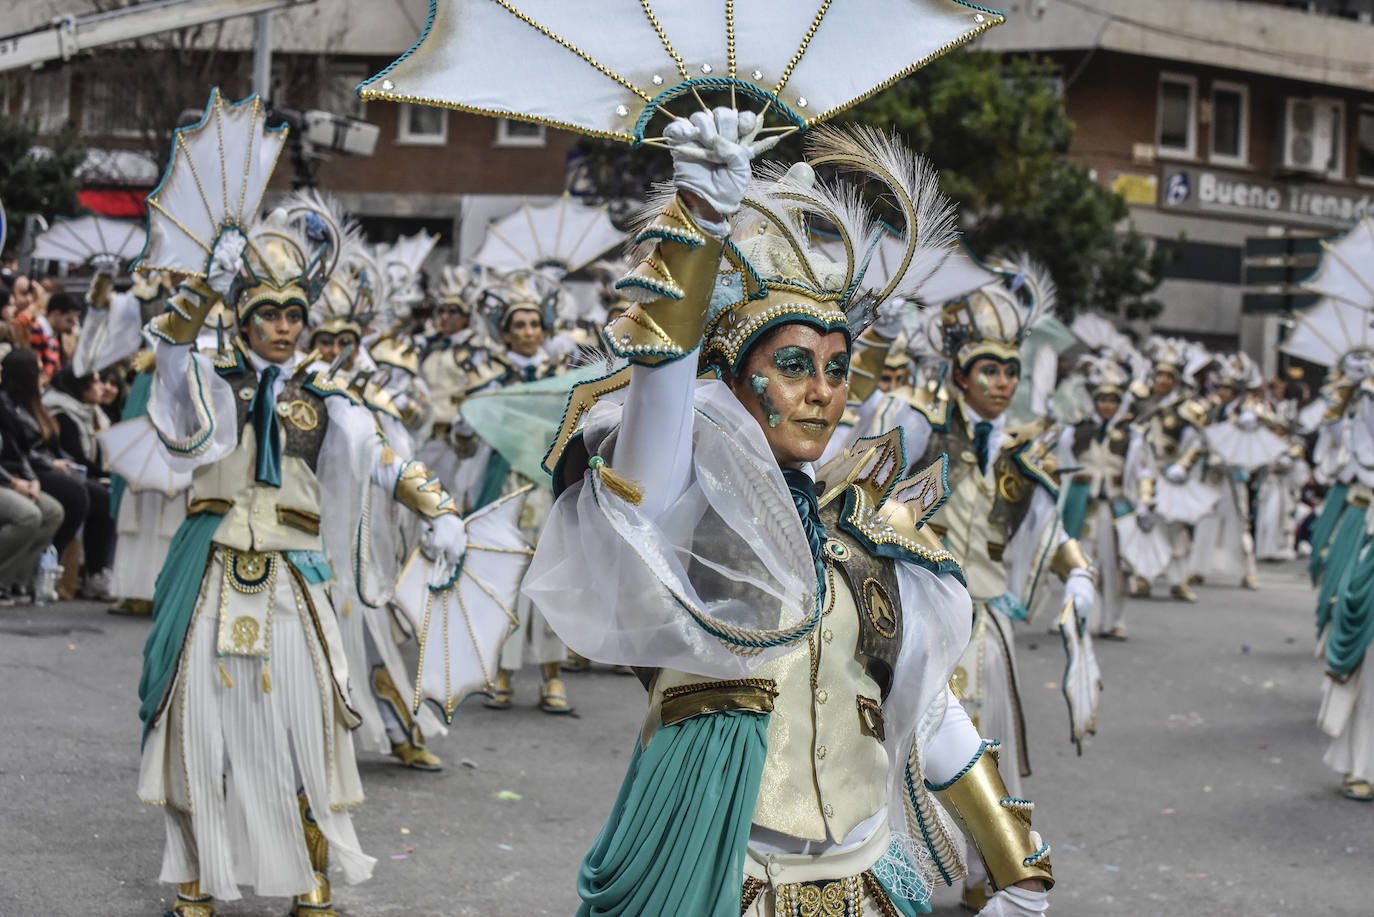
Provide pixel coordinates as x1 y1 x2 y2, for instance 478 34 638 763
927 742 1054 888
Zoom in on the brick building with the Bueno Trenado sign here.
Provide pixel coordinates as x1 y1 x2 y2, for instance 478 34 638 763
981 0 1374 371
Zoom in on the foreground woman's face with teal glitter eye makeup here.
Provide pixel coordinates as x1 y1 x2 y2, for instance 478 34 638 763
730 323 849 467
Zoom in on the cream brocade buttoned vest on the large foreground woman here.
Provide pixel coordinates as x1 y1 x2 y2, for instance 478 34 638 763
644 573 889 843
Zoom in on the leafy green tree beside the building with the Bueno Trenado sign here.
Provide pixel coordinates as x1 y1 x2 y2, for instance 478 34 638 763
568 51 1167 319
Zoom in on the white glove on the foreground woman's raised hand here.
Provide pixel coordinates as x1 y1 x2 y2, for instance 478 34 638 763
664 107 780 216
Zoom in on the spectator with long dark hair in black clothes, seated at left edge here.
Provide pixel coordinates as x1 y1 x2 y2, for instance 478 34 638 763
0 351 114 598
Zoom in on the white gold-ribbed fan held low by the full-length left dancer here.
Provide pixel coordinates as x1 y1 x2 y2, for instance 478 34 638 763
392 487 534 723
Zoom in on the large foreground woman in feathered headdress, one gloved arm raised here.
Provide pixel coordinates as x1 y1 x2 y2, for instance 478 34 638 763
525 109 1052 917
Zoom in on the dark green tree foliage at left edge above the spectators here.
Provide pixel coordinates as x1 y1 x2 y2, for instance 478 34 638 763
0 114 85 254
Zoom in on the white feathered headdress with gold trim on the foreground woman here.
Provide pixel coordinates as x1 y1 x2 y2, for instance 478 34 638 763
632 126 954 373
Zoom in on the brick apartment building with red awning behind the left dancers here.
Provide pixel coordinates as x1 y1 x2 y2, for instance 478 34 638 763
0 0 576 265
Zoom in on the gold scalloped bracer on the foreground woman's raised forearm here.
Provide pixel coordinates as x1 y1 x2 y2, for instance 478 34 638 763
603 195 723 366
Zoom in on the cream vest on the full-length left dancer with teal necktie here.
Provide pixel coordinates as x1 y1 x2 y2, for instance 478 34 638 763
191 425 320 551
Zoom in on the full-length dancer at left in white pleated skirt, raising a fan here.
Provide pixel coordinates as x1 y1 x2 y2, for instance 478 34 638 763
139 92 466 917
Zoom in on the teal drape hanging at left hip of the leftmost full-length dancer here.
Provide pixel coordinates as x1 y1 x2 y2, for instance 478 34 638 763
139 513 220 740
